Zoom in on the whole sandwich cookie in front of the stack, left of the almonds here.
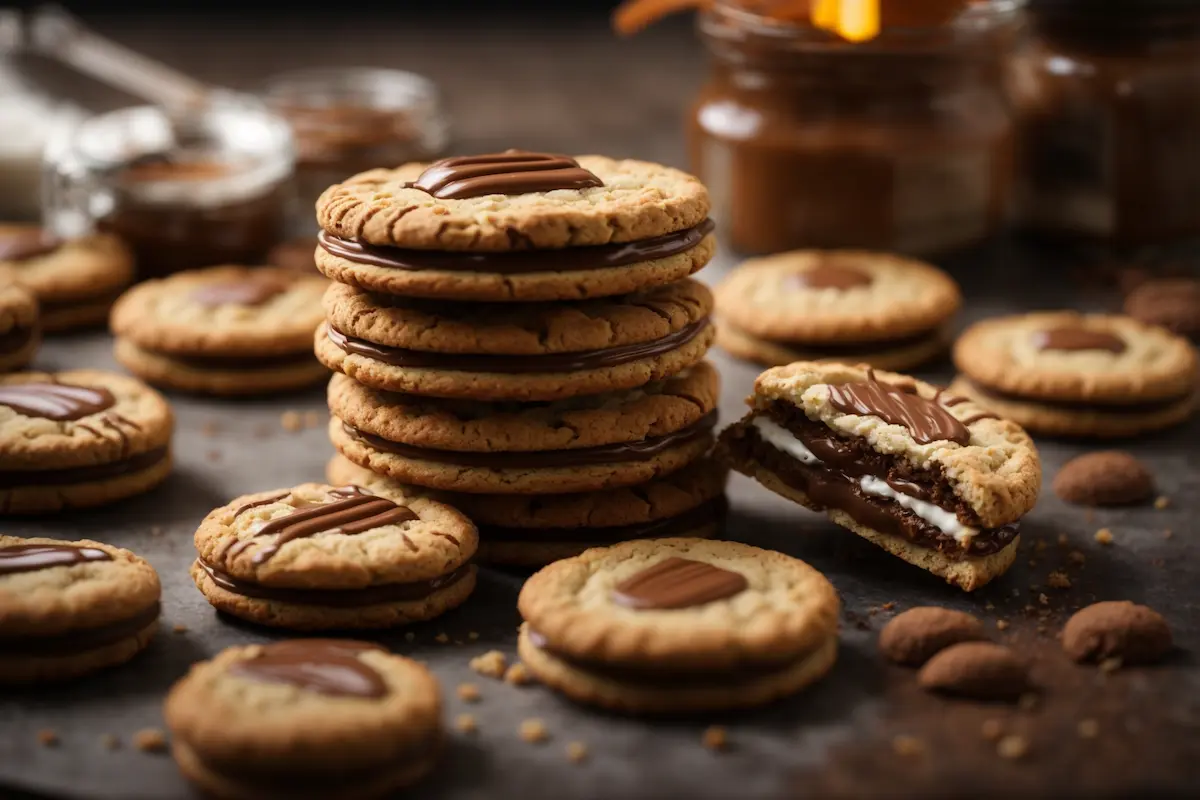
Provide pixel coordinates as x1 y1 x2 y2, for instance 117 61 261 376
517 539 840 714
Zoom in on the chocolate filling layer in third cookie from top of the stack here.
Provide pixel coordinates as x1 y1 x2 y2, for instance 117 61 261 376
342 410 716 469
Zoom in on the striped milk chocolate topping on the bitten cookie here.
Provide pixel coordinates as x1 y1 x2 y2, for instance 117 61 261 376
829 372 971 445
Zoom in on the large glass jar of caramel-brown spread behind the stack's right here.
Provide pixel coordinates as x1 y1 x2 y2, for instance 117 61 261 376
689 0 1020 255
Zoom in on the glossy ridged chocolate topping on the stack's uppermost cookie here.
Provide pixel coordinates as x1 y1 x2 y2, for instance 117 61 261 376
408 150 604 200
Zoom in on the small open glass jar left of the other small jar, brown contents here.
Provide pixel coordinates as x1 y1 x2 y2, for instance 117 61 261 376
43 92 293 277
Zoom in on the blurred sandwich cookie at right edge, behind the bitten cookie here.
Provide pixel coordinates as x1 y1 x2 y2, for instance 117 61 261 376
950 312 1198 437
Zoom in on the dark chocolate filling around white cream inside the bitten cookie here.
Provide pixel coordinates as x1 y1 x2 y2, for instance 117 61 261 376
726 402 1018 559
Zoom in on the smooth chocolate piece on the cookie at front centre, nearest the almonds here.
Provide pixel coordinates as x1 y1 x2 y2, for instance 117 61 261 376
612 557 750 610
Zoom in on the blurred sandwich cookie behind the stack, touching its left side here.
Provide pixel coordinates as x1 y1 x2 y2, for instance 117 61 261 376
112 266 328 395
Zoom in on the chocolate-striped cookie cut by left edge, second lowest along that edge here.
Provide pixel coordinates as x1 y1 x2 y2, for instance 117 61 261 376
0 369 174 513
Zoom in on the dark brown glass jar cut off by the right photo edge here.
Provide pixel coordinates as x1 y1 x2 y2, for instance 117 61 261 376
1010 0 1200 247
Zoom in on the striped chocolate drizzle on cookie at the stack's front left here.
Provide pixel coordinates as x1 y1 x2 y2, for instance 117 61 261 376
227 486 420 564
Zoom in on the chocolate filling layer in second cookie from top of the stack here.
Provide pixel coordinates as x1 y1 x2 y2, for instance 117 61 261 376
328 317 708 374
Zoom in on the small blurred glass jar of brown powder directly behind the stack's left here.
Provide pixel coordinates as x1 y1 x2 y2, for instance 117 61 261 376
263 68 449 233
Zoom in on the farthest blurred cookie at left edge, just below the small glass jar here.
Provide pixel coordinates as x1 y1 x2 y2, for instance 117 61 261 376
0 224 133 332
